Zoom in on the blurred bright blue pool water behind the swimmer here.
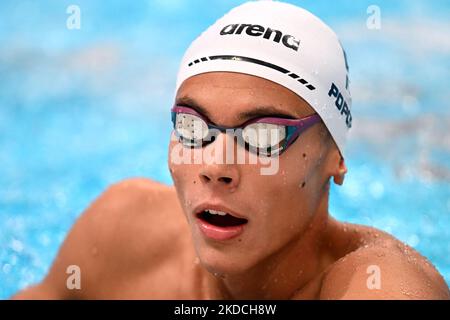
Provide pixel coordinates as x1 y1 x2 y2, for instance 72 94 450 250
0 0 450 299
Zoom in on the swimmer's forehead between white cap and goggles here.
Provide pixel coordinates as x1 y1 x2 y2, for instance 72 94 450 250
176 72 314 118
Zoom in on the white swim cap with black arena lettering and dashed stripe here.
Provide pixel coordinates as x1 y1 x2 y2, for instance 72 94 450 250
176 0 352 155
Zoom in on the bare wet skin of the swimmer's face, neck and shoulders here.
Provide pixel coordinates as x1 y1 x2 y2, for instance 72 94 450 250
14 72 450 299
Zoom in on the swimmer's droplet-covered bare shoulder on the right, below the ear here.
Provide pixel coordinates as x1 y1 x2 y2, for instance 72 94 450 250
320 224 450 299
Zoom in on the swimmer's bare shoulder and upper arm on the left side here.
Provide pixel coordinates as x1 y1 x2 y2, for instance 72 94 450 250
16 178 186 298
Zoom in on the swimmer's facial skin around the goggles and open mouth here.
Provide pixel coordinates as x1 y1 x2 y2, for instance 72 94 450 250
169 72 338 274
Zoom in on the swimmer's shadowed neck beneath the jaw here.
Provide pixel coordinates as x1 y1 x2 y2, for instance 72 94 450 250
209 191 328 299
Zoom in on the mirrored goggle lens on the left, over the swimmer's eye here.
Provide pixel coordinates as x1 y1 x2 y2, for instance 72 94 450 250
174 113 208 147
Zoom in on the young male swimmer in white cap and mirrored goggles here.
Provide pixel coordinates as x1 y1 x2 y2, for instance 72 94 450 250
15 1 449 299
